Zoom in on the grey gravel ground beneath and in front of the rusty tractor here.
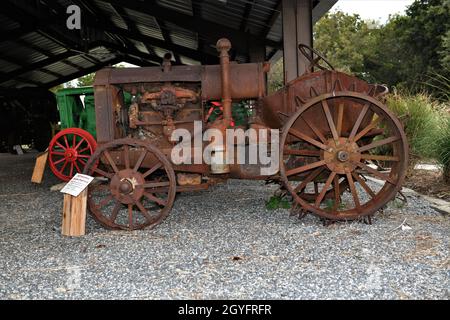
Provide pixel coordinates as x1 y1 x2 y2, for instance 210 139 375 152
0 154 450 299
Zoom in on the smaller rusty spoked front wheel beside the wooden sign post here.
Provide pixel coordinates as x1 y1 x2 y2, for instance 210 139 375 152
85 138 176 230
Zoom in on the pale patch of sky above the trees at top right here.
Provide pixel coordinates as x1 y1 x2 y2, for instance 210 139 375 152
331 0 414 23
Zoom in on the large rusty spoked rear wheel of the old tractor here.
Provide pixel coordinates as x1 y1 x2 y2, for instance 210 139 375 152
280 92 408 220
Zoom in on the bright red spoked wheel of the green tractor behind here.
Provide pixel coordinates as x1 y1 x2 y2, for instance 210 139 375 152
48 128 97 181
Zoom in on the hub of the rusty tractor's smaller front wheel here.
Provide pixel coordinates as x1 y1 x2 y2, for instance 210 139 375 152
110 169 145 204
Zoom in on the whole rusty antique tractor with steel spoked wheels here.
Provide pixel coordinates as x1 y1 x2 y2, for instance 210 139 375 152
84 39 408 230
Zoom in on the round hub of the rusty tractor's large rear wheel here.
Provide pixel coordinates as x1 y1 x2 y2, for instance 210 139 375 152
323 138 361 174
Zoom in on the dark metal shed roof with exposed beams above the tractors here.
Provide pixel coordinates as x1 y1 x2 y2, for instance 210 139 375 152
0 0 337 88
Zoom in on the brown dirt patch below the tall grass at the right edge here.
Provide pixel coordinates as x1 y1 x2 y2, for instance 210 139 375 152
404 169 450 201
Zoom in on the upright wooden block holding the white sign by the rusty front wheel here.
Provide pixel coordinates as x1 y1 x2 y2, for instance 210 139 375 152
61 188 87 237
